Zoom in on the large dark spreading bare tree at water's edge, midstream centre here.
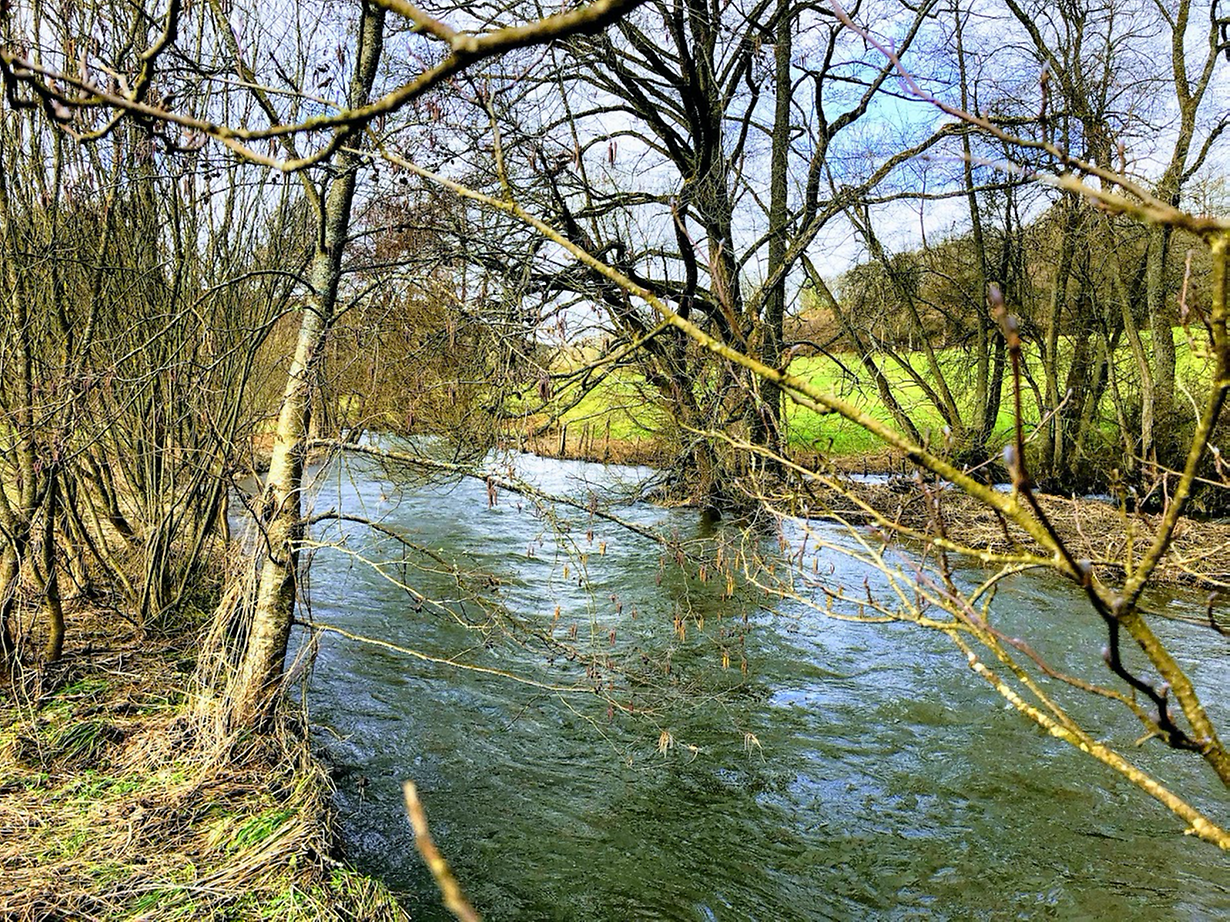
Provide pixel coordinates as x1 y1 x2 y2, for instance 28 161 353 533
457 1 936 508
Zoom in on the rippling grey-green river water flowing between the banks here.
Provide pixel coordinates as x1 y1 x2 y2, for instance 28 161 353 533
290 456 1230 920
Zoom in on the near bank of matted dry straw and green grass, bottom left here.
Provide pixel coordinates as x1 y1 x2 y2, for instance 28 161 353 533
0 607 406 922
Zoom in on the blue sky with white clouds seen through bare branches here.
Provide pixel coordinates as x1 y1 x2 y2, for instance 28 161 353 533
7 0 1230 344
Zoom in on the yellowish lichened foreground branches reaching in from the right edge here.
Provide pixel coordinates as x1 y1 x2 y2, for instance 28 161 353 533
396 0 1230 848
